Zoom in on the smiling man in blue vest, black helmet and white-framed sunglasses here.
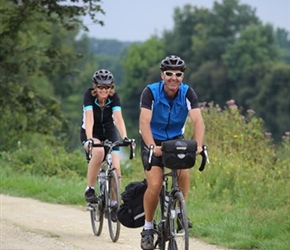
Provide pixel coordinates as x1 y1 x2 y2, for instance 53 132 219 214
139 55 205 249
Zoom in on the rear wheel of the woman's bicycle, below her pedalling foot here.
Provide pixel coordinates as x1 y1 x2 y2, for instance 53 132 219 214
89 182 105 236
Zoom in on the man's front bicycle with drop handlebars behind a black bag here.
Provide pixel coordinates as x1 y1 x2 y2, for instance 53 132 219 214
147 140 209 250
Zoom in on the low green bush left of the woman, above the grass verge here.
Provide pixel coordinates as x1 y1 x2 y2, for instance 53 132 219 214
1 136 87 179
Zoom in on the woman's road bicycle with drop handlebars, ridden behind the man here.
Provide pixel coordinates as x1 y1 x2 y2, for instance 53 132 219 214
87 139 135 242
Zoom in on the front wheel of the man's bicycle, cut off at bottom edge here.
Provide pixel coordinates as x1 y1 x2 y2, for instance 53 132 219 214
167 191 189 250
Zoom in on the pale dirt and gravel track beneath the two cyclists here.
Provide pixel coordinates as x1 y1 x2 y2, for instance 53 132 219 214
0 194 227 250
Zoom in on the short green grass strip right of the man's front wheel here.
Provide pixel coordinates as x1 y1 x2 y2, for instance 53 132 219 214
189 202 290 250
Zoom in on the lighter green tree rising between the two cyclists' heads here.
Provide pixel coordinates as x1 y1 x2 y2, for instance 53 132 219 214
120 36 165 137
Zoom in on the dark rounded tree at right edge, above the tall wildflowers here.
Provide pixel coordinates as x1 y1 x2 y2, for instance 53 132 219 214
240 62 290 141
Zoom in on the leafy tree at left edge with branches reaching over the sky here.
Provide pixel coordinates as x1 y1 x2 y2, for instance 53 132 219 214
0 0 103 150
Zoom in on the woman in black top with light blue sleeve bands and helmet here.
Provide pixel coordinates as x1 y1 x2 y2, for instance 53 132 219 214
80 69 127 203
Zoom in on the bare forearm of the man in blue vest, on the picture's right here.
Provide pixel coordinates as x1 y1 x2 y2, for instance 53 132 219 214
189 108 205 153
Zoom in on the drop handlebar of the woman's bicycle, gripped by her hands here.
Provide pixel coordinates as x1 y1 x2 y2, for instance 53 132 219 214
89 139 136 160
